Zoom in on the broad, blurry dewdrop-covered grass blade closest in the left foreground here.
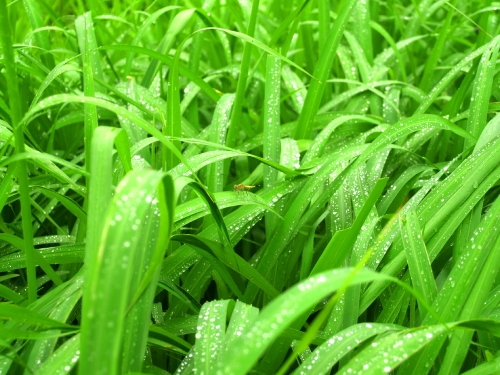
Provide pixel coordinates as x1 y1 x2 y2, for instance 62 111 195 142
79 170 171 375
